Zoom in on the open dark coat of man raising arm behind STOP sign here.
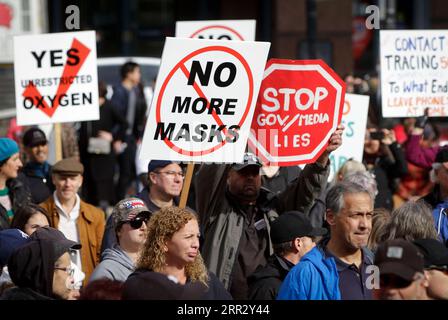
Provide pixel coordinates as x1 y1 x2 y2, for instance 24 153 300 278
195 163 330 289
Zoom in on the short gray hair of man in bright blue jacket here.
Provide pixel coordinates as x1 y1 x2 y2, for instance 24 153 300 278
325 181 374 214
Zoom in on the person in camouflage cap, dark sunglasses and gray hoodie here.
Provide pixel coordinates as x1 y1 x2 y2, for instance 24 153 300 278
90 198 150 281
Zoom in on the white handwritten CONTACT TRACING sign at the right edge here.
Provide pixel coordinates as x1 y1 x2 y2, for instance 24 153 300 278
380 30 448 117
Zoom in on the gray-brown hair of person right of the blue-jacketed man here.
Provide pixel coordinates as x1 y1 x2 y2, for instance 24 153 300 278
383 200 438 241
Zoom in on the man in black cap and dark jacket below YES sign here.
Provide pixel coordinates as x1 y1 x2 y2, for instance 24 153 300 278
19 128 54 204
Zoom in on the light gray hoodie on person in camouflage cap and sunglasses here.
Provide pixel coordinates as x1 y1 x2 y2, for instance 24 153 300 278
89 244 135 282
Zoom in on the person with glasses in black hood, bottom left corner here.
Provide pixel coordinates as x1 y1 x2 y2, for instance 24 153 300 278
1 227 81 300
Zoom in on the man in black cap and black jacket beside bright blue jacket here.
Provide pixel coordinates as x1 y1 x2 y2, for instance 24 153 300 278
248 211 327 300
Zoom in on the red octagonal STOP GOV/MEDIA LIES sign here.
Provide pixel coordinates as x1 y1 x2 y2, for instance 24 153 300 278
249 59 345 166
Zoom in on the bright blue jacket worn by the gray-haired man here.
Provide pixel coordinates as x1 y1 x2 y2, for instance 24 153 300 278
277 247 341 300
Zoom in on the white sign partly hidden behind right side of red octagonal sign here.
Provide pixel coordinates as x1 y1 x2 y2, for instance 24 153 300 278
328 94 369 181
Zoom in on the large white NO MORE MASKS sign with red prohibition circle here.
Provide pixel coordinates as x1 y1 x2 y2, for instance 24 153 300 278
140 38 270 163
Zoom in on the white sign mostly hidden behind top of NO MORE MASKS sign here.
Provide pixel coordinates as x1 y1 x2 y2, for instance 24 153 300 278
176 20 256 41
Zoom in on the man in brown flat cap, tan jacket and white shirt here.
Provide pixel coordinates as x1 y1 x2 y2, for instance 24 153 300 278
40 158 105 282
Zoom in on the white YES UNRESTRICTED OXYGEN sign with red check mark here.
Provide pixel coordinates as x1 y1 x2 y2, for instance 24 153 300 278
14 31 99 125
